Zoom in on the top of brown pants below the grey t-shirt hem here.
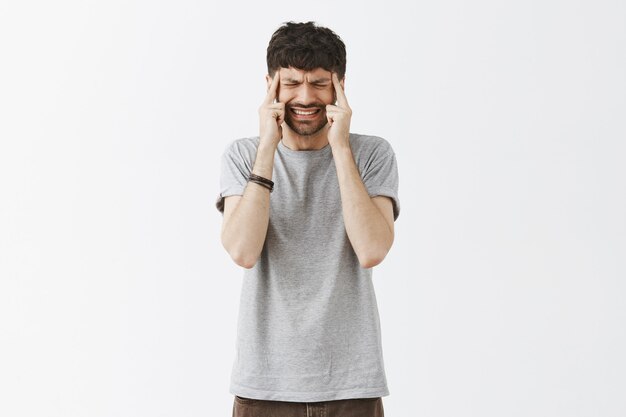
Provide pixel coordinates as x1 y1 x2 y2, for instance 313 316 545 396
233 396 385 417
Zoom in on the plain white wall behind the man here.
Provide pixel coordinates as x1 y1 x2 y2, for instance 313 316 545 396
0 0 626 417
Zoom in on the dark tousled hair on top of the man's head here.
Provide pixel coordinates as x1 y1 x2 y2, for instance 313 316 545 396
267 22 346 80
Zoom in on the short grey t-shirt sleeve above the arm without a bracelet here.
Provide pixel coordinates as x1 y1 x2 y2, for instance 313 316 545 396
362 149 400 221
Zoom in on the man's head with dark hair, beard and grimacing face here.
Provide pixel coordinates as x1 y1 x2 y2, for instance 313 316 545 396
266 22 346 136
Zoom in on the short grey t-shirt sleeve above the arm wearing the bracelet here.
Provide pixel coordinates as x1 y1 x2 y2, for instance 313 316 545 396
215 141 250 214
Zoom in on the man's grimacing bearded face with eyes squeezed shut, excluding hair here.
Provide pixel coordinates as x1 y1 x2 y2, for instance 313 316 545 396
266 67 343 136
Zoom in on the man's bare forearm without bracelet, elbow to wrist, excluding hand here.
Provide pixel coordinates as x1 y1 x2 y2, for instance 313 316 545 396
333 146 393 268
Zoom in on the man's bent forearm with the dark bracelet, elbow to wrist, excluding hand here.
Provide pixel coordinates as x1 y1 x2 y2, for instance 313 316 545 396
222 143 276 268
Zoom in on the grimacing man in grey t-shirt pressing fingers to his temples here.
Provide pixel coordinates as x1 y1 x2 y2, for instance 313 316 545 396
217 22 400 417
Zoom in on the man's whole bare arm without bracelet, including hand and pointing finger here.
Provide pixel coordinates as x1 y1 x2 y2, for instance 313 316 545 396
326 73 394 268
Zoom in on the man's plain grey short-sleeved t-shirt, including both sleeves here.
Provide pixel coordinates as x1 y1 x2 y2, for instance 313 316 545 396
216 133 400 402
